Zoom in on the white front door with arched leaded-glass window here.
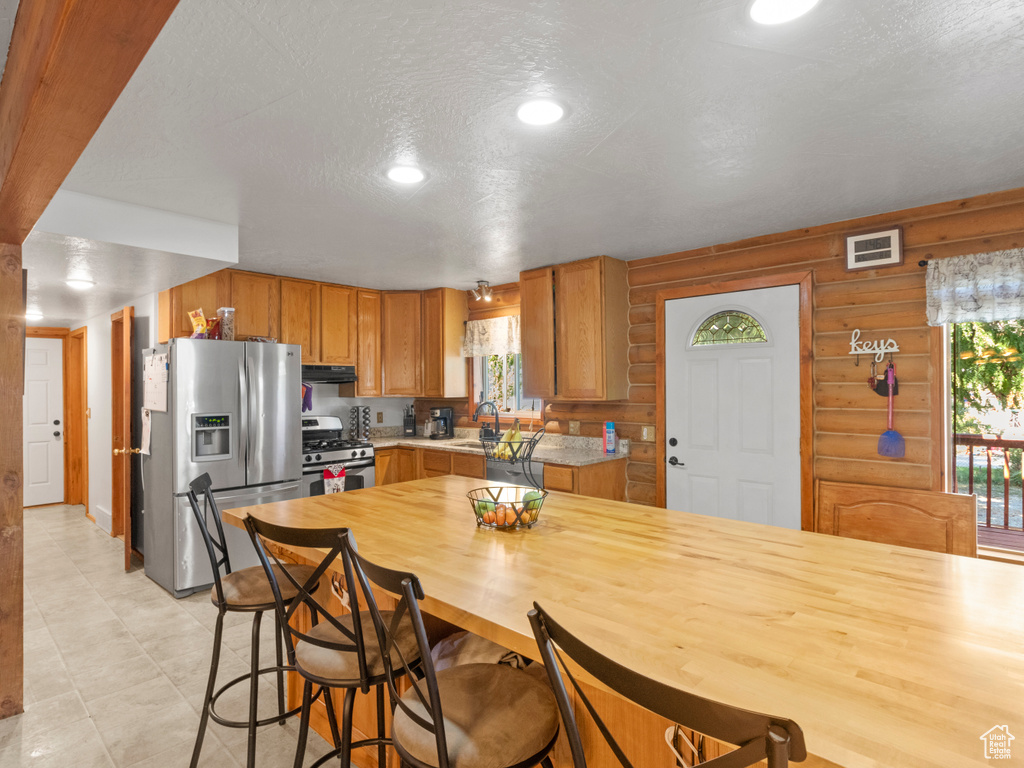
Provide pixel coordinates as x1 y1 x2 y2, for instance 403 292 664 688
665 286 800 529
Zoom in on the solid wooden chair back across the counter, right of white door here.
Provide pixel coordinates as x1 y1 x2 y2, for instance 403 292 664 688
814 480 978 557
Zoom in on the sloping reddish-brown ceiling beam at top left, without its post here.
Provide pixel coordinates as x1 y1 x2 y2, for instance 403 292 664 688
0 0 178 245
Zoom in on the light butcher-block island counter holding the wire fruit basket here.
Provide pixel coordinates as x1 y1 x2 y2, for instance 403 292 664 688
224 476 1024 768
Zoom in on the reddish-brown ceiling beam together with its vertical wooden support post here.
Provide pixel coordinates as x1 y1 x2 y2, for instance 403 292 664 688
0 0 178 719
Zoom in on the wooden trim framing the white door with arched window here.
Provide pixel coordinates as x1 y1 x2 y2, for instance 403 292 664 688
654 271 814 530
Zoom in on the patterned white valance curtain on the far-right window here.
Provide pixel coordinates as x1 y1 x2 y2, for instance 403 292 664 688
927 248 1024 326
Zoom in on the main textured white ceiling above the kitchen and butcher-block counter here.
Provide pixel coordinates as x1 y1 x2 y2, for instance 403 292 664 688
49 0 1024 288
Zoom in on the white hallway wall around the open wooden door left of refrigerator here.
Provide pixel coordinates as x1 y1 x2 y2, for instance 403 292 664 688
86 293 157 532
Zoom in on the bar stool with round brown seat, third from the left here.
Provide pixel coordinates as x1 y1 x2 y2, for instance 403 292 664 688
343 534 558 768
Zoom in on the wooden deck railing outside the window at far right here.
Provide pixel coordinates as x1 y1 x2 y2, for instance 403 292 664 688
952 434 1024 548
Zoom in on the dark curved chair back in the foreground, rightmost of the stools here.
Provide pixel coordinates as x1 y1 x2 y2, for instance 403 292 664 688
528 603 807 768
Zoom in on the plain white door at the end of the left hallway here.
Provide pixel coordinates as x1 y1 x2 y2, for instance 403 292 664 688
23 338 65 507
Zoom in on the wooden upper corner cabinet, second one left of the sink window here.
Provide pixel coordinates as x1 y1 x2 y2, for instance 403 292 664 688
381 291 423 397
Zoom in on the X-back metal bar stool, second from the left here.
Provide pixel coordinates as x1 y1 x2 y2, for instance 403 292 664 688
246 516 407 768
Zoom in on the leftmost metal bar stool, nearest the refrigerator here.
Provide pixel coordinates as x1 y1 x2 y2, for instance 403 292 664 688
186 473 318 768
